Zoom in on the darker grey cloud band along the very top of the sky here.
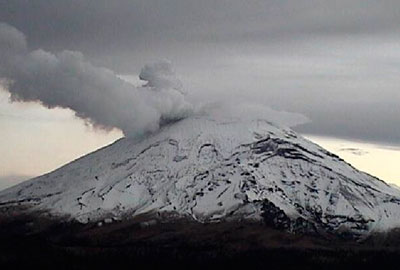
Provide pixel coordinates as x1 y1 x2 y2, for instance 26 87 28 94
0 0 400 65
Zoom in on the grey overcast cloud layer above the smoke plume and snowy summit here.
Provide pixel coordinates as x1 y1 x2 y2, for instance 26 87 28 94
0 0 400 186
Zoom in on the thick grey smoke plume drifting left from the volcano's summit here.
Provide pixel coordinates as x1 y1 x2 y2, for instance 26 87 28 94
0 23 193 137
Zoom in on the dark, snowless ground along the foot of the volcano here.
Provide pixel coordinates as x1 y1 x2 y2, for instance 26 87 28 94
0 211 400 270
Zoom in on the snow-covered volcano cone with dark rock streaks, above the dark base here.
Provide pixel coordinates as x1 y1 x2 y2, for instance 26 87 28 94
0 112 400 234
